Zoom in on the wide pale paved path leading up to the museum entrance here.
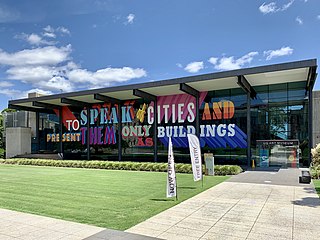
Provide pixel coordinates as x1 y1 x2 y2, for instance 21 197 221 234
127 169 320 240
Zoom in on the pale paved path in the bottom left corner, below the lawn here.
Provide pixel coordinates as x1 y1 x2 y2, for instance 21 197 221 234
0 209 156 240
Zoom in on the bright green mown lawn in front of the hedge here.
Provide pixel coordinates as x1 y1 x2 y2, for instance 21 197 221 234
0 165 228 230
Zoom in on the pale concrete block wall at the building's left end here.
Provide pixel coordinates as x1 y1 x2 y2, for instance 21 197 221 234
6 127 31 158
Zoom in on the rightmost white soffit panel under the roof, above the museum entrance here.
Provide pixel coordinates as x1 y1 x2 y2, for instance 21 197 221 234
245 68 309 87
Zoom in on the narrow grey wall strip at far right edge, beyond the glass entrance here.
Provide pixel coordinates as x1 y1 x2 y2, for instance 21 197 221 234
312 91 320 146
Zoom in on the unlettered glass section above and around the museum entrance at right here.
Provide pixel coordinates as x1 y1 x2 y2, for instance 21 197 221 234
251 82 309 165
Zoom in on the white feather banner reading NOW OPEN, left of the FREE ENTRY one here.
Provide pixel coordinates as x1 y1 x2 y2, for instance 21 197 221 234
167 137 177 197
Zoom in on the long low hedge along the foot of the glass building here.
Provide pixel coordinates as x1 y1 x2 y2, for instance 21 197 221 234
0 158 242 176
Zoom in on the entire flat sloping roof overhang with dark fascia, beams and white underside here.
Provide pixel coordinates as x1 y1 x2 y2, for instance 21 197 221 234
8 59 317 112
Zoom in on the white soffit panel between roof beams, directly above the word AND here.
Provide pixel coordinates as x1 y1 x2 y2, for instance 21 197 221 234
187 77 239 92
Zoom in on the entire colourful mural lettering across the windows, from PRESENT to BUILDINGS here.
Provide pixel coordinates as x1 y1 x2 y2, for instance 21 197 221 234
47 92 247 148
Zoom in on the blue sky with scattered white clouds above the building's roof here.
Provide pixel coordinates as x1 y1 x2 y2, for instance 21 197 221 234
0 0 320 110
